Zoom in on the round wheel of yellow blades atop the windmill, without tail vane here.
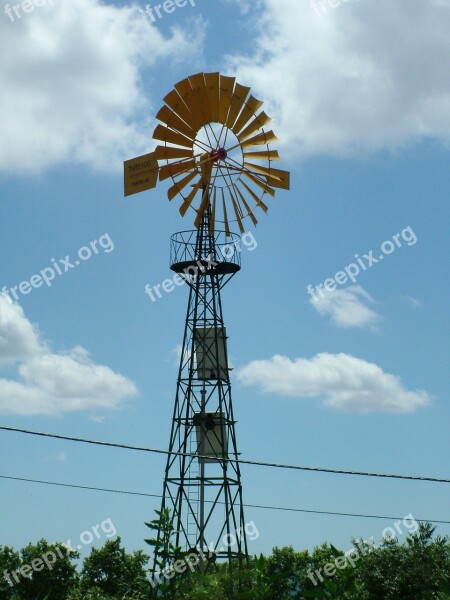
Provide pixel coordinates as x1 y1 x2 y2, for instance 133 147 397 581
146 72 289 235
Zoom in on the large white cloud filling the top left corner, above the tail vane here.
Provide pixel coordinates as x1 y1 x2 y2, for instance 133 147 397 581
0 0 204 173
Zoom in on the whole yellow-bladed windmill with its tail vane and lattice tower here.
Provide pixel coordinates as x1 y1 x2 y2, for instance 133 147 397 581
125 73 289 584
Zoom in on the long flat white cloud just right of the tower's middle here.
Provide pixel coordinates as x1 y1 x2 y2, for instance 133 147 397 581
237 352 431 413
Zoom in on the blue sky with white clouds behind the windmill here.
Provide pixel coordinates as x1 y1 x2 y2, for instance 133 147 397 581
0 0 450 568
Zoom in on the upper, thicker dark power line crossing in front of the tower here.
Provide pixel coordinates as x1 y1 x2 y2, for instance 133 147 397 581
0 426 450 483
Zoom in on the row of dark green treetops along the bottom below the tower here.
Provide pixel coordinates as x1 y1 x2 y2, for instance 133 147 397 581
0 511 450 600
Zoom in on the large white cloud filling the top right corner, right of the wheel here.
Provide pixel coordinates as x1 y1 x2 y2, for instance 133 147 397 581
228 0 450 157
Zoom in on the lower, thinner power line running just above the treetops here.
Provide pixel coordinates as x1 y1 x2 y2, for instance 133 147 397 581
0 475 450 525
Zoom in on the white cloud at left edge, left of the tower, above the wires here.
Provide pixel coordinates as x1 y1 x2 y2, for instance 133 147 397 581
0 295 137 416
